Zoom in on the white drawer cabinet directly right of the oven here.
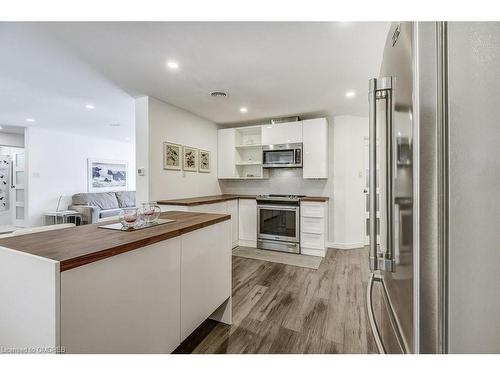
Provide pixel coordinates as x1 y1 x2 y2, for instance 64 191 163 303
300 202 328 257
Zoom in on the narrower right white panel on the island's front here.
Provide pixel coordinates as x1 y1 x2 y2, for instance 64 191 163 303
180 221 231 341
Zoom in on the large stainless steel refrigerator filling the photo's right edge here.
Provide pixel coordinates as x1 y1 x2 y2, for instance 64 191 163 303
367 22 500 353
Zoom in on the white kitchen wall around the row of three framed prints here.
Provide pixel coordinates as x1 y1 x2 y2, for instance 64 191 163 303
136 97 221 200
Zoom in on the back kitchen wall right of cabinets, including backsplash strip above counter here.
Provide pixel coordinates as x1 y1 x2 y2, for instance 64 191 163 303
220 116 368 248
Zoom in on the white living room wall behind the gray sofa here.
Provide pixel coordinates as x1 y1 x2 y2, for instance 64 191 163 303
26 128 135 226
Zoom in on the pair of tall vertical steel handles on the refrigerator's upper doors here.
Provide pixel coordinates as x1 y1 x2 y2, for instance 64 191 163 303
368 77 395 272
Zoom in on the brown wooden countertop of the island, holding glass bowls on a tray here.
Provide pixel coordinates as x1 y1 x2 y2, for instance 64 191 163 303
0 211 231 272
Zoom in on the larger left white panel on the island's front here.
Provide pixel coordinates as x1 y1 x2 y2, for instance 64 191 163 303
61 239 182 353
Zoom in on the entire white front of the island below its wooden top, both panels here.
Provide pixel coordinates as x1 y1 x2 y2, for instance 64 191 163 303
59 220 232 354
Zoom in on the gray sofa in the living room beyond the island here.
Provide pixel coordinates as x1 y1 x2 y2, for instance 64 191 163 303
68 191 136 224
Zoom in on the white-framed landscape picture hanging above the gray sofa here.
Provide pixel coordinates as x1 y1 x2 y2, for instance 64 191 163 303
87 159 128 193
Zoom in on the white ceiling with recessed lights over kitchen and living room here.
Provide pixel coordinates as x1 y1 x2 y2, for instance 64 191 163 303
0 22 389 138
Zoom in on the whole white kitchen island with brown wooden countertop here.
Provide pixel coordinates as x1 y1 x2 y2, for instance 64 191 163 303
0 211 231 353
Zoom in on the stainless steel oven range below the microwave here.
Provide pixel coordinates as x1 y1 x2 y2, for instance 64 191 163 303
257 195 300 253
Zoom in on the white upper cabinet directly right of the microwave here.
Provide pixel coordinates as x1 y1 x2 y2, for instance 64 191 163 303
302 118 328 178
